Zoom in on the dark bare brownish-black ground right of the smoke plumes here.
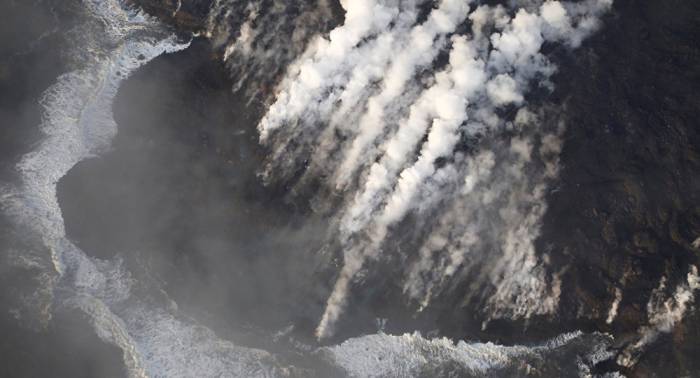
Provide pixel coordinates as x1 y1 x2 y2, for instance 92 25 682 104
540 0 700 376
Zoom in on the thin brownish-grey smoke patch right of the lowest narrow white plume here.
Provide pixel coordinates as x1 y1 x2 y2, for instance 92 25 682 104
404 110 563 317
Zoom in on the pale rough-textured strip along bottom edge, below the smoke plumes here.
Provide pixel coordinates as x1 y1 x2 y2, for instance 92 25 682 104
318 332 610 378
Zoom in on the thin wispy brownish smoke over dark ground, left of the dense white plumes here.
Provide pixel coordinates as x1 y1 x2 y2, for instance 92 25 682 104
206 0 336 100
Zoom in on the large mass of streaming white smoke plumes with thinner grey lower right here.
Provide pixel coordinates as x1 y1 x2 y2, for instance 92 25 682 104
253 0 612 338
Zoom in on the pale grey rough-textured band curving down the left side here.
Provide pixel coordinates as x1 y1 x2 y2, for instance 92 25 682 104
3 0 284 377
